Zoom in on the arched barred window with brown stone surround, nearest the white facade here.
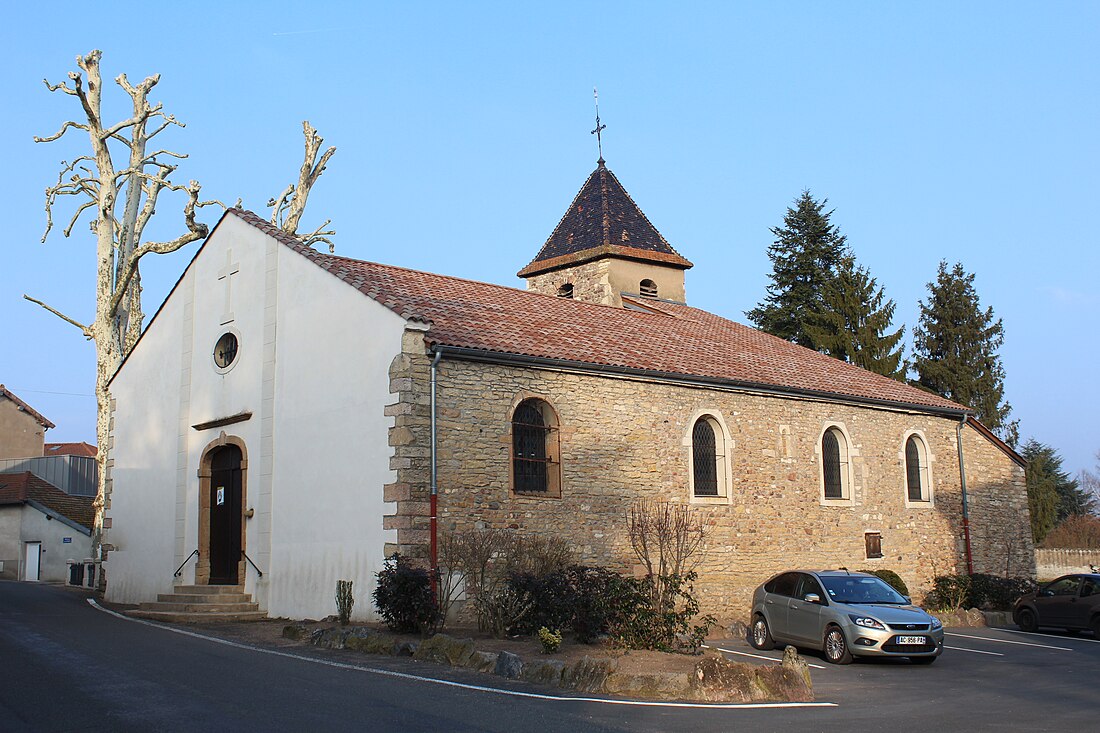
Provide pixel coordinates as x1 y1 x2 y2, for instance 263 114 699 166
512 398 561 496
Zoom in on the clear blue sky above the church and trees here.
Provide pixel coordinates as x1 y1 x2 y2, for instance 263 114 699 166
0 0 1100 472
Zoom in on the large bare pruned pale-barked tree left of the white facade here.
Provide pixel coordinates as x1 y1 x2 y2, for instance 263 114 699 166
23 51 224 572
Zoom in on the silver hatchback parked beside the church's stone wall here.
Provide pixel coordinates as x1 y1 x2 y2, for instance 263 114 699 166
749 570 944 665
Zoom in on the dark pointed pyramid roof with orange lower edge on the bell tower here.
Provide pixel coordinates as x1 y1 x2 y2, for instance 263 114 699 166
518 158 692 277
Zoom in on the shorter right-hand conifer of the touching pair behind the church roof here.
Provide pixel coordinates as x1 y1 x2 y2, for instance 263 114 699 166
805 254 909 381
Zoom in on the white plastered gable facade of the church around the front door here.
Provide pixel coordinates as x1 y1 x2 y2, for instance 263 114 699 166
105 216 405 619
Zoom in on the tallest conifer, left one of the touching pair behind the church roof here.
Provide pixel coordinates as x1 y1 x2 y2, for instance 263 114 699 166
745 190 846 349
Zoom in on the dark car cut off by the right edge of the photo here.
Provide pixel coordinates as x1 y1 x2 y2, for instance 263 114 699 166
1012 572 1100 638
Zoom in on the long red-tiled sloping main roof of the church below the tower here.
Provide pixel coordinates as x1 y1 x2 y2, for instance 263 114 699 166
230 209 967 414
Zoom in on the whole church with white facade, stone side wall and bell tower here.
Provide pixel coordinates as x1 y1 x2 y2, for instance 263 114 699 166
103 158 1034 619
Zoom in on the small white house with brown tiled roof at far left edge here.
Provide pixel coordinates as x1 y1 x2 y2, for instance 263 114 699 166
0 471 95 582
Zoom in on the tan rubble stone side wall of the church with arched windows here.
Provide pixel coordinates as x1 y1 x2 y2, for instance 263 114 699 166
386 352 1031 620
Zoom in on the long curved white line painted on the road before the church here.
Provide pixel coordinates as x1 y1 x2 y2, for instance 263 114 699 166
88 598 838 710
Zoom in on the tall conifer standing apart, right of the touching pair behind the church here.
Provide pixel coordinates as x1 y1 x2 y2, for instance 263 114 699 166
913 261 1019 446
